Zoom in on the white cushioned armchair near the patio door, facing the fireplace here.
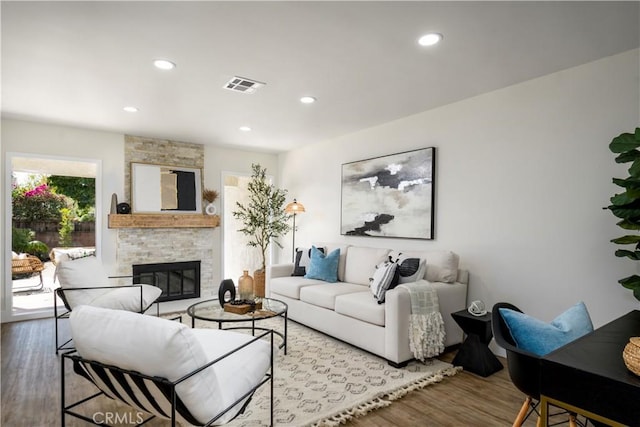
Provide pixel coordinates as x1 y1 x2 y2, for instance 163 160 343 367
53 256 162 354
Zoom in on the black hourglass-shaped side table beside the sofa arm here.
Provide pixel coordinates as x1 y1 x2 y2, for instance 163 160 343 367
451 309 503 377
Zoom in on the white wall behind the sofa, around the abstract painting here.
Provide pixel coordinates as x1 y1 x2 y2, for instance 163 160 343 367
279 50 640 332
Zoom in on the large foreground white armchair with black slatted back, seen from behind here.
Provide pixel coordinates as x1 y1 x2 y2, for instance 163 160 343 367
61 306 274 426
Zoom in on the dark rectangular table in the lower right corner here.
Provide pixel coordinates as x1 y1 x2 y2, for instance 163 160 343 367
540 310 640 426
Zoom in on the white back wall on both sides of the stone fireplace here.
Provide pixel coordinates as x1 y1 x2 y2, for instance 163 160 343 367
0 119 278 321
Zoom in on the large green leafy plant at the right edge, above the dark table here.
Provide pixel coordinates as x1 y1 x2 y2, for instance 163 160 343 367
606 127 640 301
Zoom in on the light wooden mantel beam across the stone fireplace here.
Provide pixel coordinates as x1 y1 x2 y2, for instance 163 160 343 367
109 213 220 228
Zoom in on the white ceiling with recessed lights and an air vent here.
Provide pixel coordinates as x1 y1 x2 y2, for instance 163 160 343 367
1 1 640 152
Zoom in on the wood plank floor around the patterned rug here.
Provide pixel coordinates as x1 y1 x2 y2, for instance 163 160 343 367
0 319 535 427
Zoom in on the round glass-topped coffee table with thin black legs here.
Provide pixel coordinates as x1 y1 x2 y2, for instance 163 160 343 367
187 298 288 354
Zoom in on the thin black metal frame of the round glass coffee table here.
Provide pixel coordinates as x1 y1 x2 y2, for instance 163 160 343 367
187 298 289 355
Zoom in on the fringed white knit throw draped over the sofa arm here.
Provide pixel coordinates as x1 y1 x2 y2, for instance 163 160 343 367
398 280 445 362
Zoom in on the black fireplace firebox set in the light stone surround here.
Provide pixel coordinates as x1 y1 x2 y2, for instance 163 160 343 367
133 261 200 302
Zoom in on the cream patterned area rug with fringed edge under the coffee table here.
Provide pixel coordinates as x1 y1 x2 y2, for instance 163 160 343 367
178 316 460 427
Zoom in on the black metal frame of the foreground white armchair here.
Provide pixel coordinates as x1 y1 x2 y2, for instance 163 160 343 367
60 330 274 427
